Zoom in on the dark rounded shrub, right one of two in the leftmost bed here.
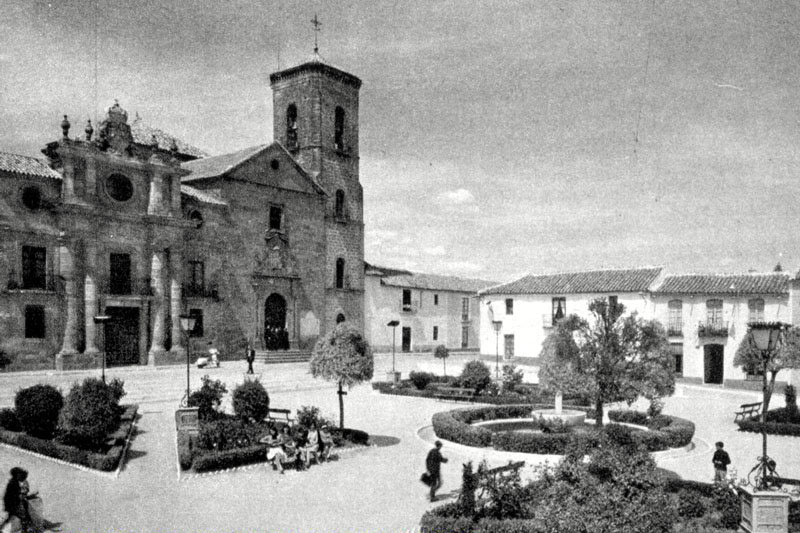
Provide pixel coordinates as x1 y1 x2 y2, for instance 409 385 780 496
59 378 122 450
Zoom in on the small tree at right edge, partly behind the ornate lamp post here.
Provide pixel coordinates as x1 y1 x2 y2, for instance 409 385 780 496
733 328 800 413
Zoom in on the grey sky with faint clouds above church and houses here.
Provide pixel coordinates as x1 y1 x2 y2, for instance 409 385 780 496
0 0 800 282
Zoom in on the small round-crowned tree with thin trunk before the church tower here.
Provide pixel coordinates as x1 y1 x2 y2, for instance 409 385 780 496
310 322 375 428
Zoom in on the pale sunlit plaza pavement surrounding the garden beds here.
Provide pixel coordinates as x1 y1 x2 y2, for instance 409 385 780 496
0 354 800 533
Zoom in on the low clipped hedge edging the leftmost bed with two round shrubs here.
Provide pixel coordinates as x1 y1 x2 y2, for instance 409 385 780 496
0 404 138 472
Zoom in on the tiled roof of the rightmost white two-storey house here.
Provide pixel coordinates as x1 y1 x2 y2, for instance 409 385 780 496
655 272 789 295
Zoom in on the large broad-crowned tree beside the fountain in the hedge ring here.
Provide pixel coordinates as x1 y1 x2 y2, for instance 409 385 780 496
539 298 675 426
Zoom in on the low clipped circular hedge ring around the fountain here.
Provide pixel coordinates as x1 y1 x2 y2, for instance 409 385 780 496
432 404 694 455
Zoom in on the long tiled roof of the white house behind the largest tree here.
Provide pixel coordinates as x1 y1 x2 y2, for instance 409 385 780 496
481 267 662 294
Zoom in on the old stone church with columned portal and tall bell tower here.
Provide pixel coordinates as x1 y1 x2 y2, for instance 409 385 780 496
0 57 364 369
